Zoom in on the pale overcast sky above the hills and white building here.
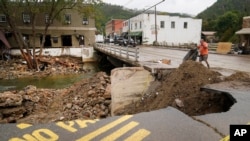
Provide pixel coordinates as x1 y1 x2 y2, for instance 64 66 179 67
103 0 217 16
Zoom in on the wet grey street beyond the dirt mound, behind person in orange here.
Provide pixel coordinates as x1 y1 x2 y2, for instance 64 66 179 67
139 47 250 72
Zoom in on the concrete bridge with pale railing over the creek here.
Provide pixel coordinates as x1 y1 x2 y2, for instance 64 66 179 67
94 43 178 73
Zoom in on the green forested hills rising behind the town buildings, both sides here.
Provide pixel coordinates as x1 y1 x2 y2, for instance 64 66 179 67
96 0 250 42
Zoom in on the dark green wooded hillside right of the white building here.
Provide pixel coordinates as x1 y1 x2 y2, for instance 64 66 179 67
196 0 250 42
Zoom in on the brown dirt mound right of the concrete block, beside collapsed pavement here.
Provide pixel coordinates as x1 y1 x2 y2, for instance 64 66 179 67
117 61 250 116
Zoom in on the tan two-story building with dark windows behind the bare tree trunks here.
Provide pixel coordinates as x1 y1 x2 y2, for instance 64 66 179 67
0 9 96 48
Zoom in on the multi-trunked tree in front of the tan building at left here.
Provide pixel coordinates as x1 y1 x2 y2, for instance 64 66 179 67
0 0 101 69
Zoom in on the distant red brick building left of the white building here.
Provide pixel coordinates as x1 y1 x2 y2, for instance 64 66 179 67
105 19 124 38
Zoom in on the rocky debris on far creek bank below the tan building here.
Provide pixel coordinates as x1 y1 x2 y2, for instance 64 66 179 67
0 56 87 79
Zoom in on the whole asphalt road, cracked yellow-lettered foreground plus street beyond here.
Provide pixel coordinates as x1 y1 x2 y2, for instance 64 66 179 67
0 47 250 141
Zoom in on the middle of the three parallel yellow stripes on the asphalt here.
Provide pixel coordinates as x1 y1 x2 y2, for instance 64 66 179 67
101 121 139 141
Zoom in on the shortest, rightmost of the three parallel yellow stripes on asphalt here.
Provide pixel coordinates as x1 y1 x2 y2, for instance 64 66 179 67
124 129 150 141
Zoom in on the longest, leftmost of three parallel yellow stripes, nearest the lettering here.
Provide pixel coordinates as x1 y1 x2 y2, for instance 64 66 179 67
76 115 132 141
